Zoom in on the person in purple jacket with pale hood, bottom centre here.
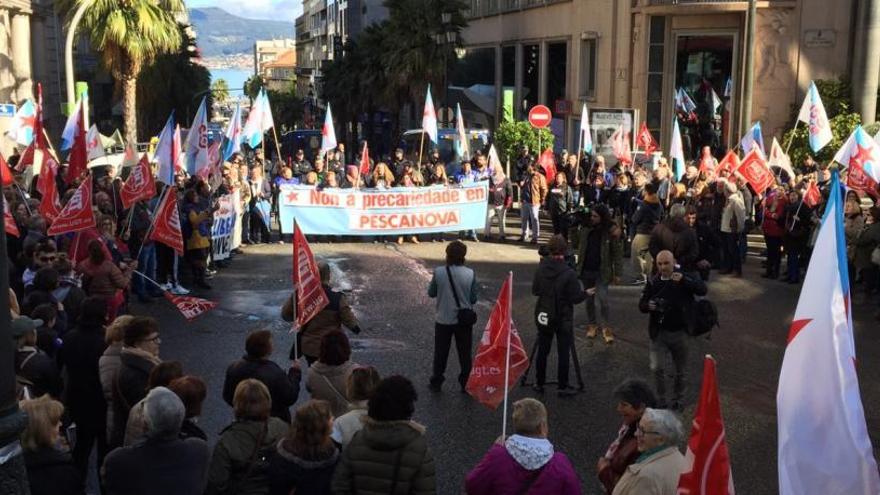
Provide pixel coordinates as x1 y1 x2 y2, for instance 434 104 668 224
465 398 581 495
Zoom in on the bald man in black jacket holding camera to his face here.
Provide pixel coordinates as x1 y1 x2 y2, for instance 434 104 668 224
639 251 706 411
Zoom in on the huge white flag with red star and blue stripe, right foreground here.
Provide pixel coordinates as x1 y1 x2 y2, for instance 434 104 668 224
776 171 880 495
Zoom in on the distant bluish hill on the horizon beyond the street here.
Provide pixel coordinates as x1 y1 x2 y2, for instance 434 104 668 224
189 7 295 57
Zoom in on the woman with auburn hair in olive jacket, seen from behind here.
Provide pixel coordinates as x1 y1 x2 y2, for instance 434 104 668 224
205 378 288 495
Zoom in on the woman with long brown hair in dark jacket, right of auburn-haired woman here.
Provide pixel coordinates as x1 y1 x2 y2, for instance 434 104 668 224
269 399 339 495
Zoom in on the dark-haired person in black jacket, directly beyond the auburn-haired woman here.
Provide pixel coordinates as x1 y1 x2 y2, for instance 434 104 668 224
223 330 302 423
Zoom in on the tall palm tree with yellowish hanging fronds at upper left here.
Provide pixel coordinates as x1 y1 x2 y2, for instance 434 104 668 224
57 0 186 143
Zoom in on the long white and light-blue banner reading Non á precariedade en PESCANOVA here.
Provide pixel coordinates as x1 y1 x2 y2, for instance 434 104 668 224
278 181 489 235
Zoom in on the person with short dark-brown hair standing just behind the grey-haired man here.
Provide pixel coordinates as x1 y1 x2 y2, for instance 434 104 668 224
110 316 162 447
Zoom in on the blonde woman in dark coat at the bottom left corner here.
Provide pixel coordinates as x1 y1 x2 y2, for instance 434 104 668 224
19 395 84 495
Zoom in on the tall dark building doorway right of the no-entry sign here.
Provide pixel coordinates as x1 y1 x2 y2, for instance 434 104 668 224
673 33 737 159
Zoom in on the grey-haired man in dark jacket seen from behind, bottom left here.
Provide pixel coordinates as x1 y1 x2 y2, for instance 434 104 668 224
102 387 211 495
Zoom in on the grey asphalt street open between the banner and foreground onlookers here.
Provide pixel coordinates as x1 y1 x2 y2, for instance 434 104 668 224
134 227 880 494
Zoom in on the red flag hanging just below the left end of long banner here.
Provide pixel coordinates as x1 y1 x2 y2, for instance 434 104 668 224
293 222 330 328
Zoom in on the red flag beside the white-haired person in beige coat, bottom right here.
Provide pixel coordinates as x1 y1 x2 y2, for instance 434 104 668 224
678 356 734 495
